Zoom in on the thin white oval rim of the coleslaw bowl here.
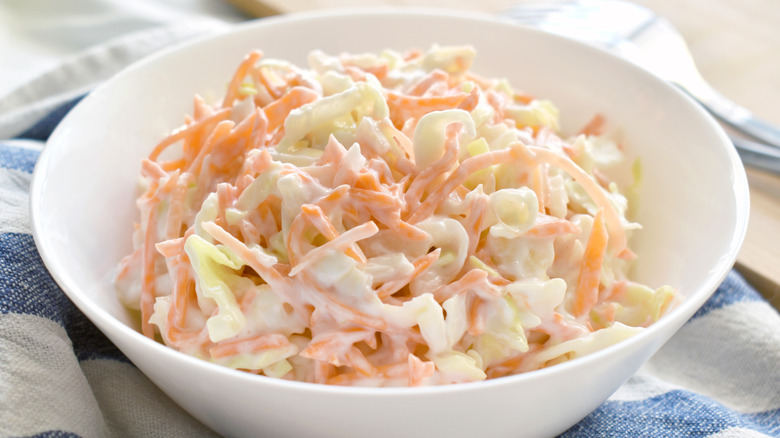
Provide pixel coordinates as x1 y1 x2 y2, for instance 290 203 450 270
30 6 750 397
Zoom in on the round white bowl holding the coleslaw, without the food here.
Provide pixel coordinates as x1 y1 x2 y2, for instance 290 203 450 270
31 9 748 437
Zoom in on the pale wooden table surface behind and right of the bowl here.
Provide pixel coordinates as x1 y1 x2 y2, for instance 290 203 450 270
228 0 780 309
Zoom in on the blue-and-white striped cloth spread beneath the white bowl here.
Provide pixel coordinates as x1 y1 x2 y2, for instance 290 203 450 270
0 102 780 438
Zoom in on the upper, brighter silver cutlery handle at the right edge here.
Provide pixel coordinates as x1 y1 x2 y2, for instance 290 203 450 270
683 88 780 149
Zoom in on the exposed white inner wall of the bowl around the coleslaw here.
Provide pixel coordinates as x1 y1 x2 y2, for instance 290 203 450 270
31 6 747 408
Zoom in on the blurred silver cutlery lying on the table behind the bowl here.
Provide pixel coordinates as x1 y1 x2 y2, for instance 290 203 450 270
503 0 780 173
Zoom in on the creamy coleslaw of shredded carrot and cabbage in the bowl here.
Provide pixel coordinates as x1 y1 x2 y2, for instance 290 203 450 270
116 46 680 386
